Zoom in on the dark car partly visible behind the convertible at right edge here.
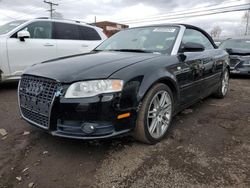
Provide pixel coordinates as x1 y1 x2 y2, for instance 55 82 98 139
220 37 250 75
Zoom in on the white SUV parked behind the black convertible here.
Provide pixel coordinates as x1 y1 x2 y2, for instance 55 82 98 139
0 18 107 82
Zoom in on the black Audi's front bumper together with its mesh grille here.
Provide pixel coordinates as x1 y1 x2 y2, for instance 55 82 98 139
18 75 140 139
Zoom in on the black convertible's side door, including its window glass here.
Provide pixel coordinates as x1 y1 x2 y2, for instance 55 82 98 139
176 29 213 105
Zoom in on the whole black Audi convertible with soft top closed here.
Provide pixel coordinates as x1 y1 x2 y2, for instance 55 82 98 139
18 24 229 143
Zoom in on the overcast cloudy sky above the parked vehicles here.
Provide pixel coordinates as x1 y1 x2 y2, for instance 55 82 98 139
0 0 250 36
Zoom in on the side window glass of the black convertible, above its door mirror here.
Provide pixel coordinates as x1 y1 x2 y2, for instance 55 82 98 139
182 29 214 50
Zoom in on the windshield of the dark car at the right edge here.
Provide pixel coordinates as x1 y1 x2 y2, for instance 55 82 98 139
220 39 250 49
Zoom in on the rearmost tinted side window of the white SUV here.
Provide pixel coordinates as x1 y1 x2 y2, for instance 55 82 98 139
79 26 101 40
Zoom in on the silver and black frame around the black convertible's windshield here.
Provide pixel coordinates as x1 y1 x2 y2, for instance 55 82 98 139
93 25 181 55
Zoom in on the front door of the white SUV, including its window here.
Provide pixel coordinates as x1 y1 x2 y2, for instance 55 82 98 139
7 21 56 75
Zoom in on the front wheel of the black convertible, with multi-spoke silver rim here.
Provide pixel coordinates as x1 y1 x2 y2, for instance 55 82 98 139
133 83 174 144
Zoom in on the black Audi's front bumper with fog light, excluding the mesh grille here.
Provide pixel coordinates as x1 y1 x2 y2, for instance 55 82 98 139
21 91 136 140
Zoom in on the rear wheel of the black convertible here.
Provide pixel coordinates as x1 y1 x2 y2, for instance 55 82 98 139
214 69 229 99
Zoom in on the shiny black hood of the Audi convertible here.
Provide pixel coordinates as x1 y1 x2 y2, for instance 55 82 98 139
24 51 159 83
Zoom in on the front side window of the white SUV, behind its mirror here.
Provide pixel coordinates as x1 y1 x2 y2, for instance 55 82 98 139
12 21 52 39
